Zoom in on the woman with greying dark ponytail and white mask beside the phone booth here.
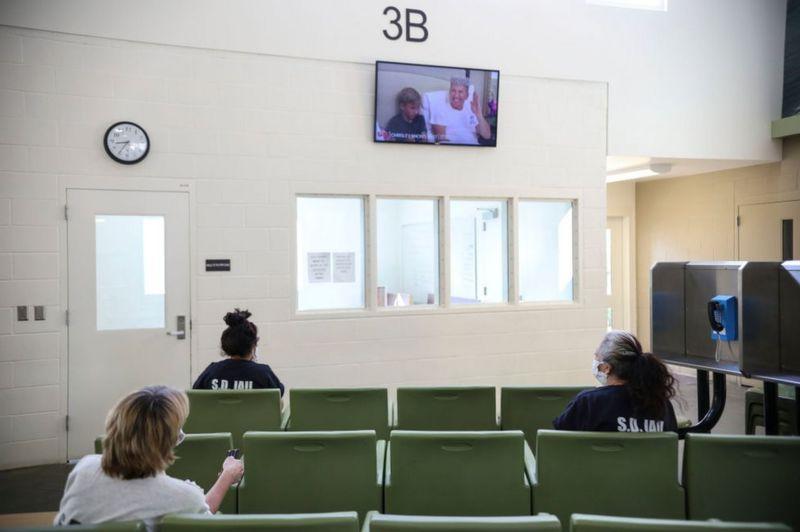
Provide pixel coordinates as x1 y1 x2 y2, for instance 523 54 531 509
553 331 678 432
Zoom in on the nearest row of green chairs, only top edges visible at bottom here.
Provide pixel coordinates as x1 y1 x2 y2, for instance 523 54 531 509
9 512 791 532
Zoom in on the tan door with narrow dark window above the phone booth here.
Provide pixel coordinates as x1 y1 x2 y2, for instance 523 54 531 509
739 201 800 261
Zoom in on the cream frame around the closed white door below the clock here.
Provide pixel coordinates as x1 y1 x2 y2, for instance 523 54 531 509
58 178 198 459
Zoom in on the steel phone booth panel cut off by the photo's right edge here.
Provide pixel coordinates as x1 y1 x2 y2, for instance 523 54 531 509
779 261 800 374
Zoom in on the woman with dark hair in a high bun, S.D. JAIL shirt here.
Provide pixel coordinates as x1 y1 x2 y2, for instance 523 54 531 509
192 308 283 395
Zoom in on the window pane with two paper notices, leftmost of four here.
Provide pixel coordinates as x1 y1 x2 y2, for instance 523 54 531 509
297 197 364 310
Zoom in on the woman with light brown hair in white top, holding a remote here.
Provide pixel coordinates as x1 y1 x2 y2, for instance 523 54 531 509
54 386 244 527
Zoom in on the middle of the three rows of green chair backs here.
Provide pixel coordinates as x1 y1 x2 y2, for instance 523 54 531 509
106 430 800 529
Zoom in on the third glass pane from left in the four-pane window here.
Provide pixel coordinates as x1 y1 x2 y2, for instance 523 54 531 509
450 200 508 305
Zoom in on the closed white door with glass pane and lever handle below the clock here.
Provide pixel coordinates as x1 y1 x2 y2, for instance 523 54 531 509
67 189 191 459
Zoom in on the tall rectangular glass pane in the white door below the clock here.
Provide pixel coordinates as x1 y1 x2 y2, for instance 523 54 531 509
94 215 165 331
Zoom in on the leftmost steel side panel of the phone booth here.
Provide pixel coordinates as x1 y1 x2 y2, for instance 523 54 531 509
650 262 686 357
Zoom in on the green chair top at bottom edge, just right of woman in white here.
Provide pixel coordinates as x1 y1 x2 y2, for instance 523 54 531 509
158 512 358 532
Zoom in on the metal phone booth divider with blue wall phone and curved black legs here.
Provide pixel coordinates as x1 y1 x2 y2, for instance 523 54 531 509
651 261 800 436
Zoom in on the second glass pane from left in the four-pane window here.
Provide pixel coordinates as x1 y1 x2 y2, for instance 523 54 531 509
377 199 439 307
